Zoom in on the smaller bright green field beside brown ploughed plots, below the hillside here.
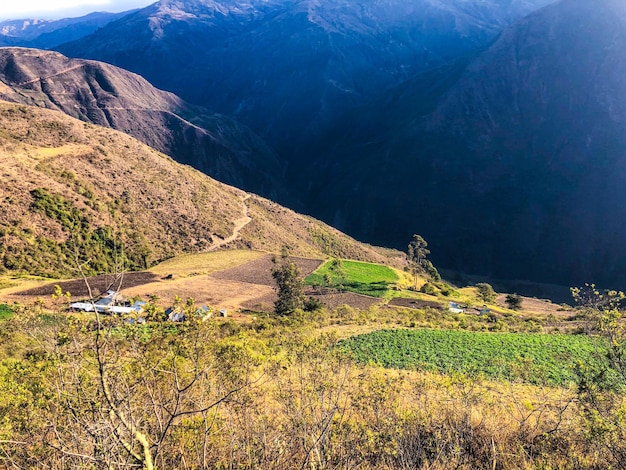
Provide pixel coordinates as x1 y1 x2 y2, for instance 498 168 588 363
305 260 399 297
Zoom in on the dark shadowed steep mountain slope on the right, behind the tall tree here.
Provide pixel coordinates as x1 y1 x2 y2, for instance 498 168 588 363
309 0 626 287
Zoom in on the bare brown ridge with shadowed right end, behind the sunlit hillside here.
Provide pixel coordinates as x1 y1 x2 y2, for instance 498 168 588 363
0 48 285 197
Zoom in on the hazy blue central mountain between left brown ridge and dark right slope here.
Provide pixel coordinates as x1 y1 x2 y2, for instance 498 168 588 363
58 0 554 152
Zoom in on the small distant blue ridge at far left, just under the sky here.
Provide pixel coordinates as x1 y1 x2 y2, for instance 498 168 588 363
0 10 135 49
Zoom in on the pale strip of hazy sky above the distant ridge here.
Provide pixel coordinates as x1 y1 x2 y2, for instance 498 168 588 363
0 0 156 21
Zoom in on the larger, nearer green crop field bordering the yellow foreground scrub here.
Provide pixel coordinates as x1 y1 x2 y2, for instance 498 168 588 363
340 330 604 385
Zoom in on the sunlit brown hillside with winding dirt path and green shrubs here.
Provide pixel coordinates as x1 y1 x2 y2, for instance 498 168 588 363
0 102 387 276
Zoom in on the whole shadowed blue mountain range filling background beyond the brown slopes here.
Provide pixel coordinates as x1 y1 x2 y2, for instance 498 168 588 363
3 0 626 287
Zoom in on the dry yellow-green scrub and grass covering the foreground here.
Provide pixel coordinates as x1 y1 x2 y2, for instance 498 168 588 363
0 298 617 470
